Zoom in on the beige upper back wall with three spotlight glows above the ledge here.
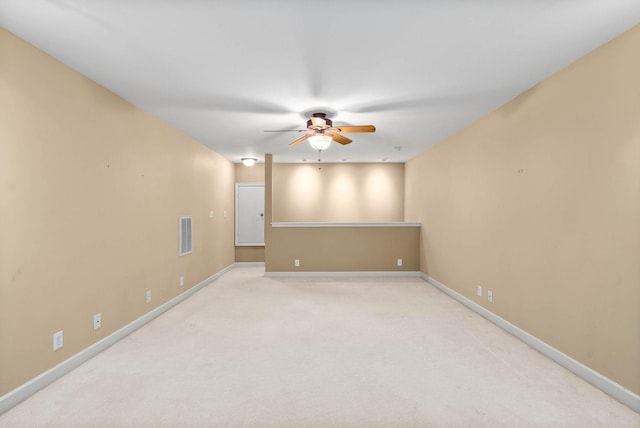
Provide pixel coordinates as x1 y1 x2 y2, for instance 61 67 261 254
273 163 404 222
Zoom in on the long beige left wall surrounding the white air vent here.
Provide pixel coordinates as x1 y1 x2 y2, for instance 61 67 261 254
0 29 234 395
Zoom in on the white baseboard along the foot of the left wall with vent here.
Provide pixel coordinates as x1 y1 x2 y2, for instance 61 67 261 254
0 264 234 415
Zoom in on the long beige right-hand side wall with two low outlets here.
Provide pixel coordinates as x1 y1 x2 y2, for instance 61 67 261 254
406 27 640 393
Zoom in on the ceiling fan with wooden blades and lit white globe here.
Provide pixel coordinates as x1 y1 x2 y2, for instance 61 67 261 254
264 113 376 151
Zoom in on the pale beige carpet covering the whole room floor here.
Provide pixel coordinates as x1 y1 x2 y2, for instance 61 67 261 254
0 267 640 428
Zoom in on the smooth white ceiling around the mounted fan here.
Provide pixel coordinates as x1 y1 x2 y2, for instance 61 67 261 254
0 0 640 162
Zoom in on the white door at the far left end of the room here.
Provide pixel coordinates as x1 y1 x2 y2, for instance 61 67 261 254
236 183 264 246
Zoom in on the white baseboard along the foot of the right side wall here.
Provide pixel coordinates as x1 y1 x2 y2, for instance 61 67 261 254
420 273 640 413
